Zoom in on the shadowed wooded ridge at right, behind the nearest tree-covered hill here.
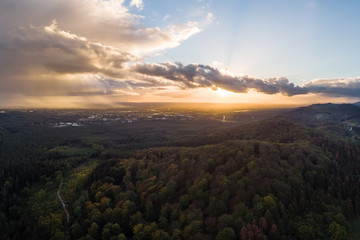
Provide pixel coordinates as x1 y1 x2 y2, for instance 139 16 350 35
191 103 360 145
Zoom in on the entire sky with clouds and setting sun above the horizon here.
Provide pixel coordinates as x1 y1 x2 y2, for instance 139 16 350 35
0 0 360 108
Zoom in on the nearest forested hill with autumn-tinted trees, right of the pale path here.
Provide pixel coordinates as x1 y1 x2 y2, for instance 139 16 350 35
77 118 360 239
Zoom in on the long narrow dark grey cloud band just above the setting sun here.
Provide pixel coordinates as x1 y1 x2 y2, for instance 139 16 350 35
134 63 308 96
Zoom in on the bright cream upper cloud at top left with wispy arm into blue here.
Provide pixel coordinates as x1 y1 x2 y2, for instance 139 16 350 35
0 0 207 54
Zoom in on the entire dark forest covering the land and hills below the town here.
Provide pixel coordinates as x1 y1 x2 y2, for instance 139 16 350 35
0 105 360 240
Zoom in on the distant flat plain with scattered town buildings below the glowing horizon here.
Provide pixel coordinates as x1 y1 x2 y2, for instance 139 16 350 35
0 104 287 128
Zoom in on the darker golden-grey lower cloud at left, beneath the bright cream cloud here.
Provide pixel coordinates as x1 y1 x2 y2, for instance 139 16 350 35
0 21 139 95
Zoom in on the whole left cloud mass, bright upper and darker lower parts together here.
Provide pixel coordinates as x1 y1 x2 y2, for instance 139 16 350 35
0 0 211 96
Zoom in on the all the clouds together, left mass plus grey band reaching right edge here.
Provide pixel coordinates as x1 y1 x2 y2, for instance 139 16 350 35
0 0 360 107
